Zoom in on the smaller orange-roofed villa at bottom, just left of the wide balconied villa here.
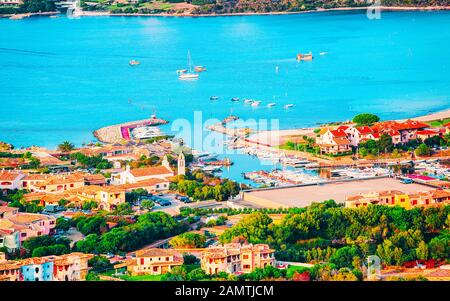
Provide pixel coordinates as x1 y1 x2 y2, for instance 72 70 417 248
127 248 183 275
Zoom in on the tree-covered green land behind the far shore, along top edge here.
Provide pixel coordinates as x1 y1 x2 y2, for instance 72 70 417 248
0 0 450 15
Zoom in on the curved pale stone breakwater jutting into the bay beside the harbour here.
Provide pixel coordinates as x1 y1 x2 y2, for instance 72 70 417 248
94 117 169 143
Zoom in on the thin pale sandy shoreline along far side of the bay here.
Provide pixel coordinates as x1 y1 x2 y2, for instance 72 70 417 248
0 5 450 19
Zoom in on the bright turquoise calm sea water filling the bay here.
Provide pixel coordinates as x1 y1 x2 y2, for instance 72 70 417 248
0 12 450 180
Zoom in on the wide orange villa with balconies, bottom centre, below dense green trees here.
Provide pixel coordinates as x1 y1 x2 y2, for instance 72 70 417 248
201 243 275 275
